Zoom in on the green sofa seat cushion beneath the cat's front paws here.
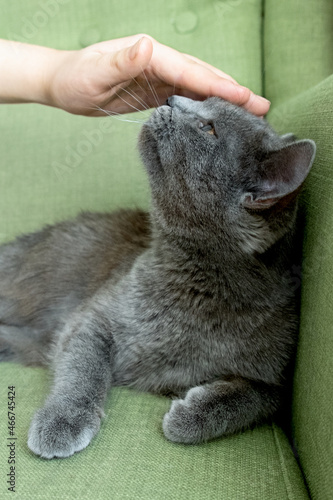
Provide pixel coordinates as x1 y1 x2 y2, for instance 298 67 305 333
0 363 308 500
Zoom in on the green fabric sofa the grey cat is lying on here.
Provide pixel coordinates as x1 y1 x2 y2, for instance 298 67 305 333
0 0 333 500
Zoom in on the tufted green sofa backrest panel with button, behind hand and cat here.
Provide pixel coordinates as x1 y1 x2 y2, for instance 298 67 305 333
0 0 262 242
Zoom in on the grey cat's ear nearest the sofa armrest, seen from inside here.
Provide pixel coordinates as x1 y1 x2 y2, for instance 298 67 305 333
243 139 316 210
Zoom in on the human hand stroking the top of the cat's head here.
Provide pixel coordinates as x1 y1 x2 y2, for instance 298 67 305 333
44 35 270 116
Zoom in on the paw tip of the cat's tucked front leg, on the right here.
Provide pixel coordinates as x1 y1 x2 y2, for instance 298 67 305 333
163 386 207 444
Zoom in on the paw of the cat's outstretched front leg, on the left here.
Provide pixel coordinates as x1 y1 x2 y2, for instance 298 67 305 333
28 404 102 458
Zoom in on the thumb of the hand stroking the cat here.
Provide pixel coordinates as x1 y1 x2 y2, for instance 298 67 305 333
100 37 153 85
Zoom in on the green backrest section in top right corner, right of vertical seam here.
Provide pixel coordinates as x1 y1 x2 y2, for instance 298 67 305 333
263 0 333 106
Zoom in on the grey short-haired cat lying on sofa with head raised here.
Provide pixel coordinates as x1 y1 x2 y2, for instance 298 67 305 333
0 96 316 458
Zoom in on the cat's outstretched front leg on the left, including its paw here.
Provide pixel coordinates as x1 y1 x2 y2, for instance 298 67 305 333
28 314 114 458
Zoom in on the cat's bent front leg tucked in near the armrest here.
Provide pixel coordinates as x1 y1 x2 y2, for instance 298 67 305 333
163 377 281 444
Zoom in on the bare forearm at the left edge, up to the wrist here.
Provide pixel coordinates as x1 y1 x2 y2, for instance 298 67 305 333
0 39 62 105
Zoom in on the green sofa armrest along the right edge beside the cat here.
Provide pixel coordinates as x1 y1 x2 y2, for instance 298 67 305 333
270 75 333 500
